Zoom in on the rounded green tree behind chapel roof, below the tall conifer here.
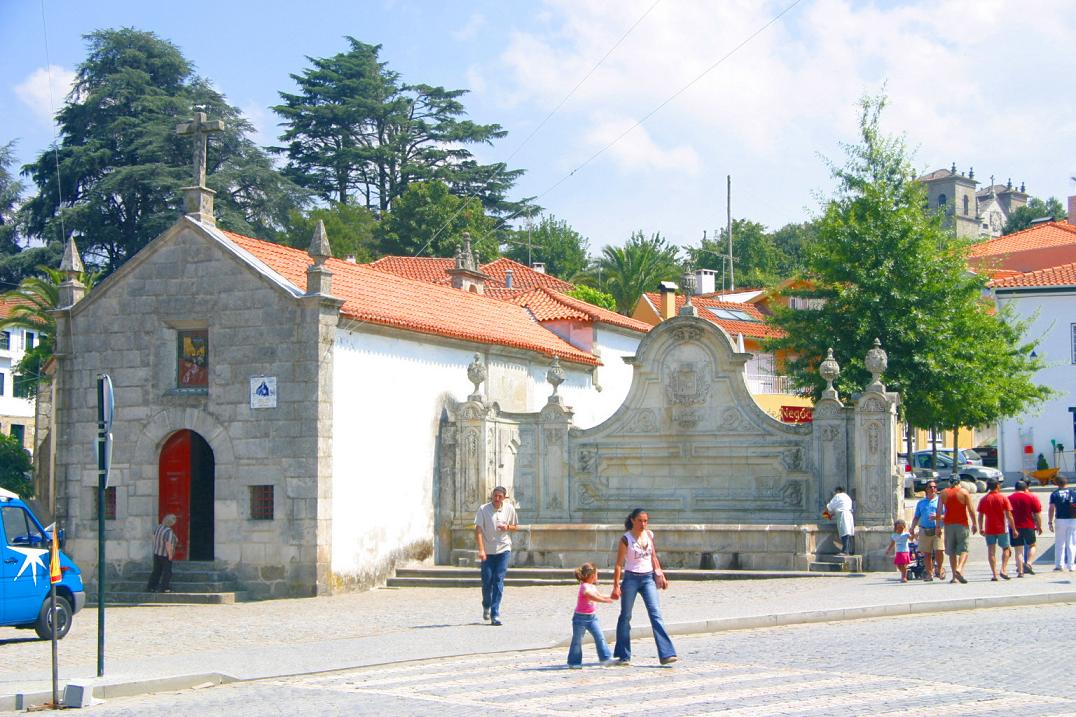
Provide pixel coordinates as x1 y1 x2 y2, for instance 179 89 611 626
378 181 500 262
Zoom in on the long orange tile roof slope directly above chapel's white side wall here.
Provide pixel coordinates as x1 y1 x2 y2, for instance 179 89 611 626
222 231 599 365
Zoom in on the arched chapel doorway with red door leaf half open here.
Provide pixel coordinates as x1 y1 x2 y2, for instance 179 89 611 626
157 430 215 560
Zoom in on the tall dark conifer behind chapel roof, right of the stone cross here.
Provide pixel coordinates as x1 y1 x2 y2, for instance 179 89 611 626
273 37 522 214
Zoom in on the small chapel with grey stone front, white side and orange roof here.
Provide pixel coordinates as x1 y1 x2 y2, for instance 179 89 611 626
38 161 628 599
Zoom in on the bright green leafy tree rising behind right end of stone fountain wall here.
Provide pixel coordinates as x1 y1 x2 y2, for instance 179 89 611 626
767 93 1050 427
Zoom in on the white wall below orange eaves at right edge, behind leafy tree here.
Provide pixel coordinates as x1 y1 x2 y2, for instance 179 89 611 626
997 289 1076 477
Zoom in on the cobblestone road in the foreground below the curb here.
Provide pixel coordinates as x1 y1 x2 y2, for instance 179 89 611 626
46 605 1076 717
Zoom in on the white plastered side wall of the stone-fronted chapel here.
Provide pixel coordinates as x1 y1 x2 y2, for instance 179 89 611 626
331 328 606 581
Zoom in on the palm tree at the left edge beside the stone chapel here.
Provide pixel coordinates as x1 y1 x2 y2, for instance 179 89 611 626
0 266 97 396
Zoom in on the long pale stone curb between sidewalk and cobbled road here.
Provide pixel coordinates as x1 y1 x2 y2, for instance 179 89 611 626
10 590 1076 711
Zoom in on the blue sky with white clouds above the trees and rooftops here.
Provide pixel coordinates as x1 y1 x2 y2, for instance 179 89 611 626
0 0 1076 252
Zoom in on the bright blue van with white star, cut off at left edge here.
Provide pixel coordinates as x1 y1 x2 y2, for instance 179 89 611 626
0 488 86 639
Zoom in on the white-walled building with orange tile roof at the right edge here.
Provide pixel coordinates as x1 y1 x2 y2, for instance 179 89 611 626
987 248 1076 479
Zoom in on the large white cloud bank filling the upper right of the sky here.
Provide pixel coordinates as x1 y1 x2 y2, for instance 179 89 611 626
497 0 1076 236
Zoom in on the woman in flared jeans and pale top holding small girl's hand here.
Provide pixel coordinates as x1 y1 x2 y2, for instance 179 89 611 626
610 508 677 665
